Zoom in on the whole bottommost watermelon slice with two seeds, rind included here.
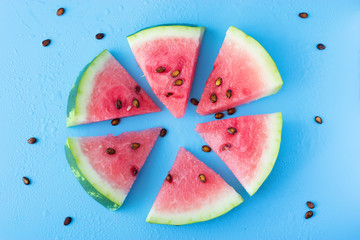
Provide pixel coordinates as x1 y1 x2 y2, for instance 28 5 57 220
146 148 243 225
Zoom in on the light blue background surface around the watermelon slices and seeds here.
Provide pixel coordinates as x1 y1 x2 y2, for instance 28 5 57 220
0 0 360 240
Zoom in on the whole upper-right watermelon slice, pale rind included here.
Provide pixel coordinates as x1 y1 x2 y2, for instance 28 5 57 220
196 27 283 115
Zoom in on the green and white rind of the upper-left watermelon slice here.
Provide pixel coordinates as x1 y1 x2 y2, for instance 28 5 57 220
66 49 111 127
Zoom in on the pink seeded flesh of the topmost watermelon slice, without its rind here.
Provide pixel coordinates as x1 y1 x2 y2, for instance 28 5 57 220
133 38 201 118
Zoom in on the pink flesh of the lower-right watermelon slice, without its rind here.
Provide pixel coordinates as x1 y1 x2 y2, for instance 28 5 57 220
195 114 270 192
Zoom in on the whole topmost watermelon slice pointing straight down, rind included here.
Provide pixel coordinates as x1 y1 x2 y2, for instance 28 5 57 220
127 25 205 118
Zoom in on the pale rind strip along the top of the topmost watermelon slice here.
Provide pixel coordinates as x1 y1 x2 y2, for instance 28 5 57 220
127 25 205 51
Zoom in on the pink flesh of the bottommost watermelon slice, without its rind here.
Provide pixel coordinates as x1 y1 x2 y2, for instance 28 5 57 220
153 148 233 215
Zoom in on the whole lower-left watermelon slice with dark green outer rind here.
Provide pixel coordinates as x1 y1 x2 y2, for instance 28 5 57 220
65 127 161 211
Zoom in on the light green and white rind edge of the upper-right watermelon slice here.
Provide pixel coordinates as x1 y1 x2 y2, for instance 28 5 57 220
226 26 283 97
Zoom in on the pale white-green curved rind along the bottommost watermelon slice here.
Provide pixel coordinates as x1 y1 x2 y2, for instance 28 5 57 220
146 186 244 225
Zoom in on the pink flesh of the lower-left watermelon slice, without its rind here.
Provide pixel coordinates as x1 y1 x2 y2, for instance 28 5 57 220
80 127 161 194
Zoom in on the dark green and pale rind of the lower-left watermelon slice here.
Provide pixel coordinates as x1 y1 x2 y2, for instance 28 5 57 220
65 138 126 211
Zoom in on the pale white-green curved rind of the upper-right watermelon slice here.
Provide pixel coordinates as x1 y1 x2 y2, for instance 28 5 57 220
225 26 283 97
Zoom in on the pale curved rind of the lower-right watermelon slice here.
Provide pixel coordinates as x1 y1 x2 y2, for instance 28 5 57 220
244 112 282 196
